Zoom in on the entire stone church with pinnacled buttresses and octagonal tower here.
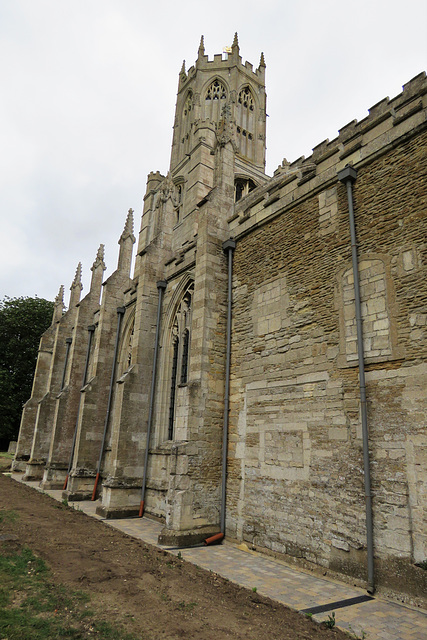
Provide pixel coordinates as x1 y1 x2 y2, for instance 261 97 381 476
14 34 427 595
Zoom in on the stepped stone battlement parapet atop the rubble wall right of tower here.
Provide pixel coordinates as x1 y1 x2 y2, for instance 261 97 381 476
231 72 427 239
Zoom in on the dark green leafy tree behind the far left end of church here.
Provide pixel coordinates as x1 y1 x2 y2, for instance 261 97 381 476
0 296 53 445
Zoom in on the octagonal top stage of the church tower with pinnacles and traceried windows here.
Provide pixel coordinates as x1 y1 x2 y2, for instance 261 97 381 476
170 33 266 211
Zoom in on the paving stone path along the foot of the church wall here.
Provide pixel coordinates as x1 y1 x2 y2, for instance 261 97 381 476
12 474 427 640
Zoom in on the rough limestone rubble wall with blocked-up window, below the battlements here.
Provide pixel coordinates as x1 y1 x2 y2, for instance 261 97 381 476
227 122 427 588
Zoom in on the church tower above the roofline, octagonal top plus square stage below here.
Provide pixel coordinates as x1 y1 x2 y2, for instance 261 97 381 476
136 33 268 272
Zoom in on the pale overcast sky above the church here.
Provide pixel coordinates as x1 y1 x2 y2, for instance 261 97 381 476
0 0 427 304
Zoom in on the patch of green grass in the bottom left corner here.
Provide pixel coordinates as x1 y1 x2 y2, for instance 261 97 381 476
0 548 140 640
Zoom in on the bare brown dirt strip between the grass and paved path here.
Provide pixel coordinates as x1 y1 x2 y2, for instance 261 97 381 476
0 475 348 640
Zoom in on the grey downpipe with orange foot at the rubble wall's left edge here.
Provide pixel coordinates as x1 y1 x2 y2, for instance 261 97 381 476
205 238 236 545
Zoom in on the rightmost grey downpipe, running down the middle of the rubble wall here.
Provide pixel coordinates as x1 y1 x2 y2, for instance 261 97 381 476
337 166 375 594
